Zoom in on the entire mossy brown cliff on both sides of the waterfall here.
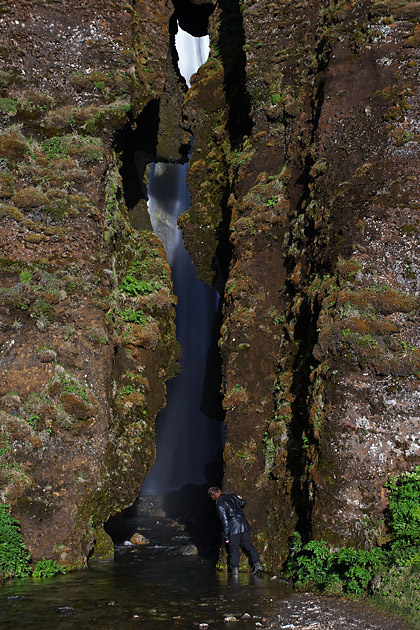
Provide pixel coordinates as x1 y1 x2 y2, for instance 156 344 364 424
0 0 420 567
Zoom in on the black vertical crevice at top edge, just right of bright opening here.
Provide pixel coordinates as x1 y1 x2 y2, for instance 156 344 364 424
217 0 253 148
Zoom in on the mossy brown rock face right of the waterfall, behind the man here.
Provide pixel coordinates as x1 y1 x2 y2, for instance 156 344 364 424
182 0 420 566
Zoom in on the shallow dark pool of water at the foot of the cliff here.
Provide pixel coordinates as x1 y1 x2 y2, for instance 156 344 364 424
0 545 290 630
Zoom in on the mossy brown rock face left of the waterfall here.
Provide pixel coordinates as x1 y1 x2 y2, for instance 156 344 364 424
0 0 179 567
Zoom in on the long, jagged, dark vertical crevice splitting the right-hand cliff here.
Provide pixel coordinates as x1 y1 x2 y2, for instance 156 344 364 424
286 34 331 542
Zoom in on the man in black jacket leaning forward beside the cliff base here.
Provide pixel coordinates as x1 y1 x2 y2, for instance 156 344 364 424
208 486 264 576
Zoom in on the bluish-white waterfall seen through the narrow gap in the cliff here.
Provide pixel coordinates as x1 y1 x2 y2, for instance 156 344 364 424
142 29 223 494
